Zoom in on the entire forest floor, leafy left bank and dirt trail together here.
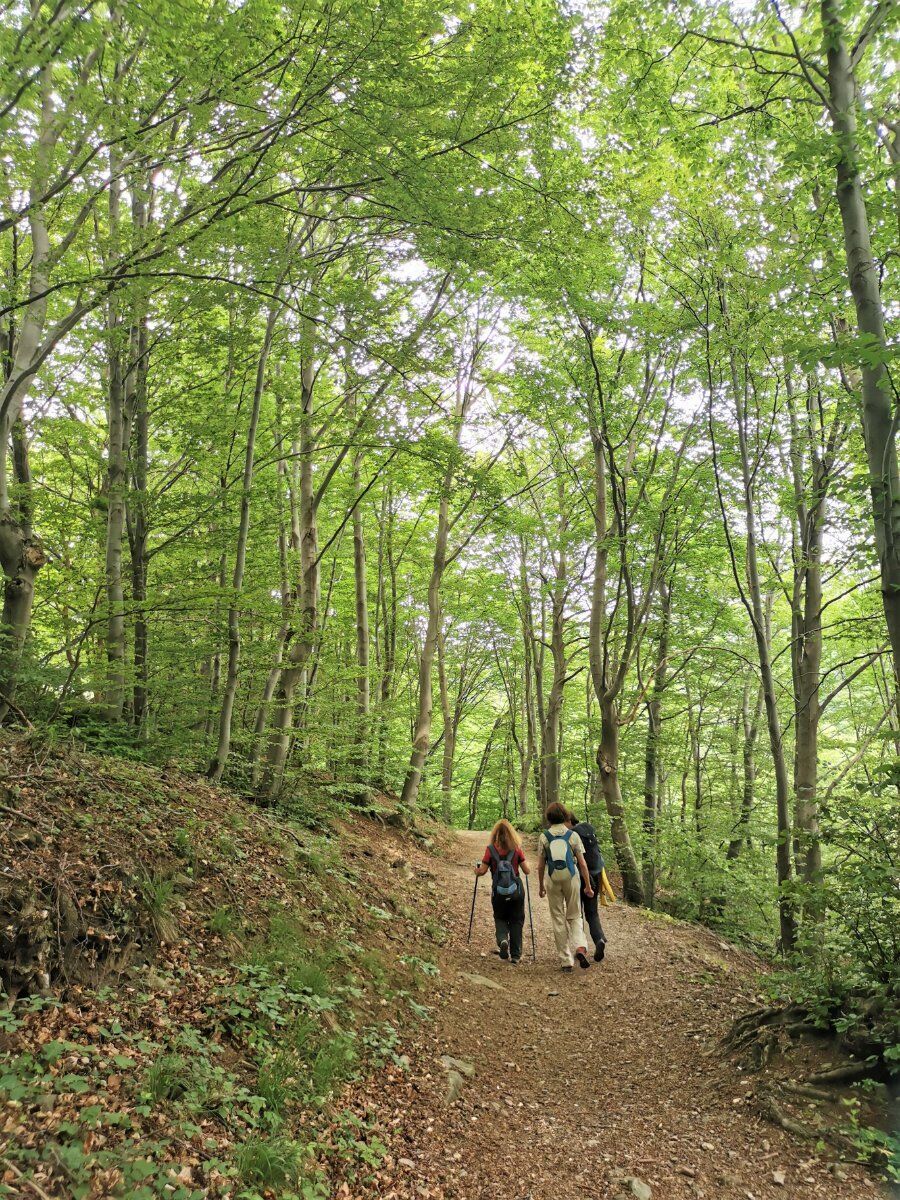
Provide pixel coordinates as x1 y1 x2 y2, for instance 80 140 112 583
0 740 887 1200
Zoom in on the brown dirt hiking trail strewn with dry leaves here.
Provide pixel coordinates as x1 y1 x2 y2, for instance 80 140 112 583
355 833 886 1200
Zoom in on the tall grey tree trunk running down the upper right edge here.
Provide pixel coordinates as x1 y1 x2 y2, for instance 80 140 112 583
821 0 900 695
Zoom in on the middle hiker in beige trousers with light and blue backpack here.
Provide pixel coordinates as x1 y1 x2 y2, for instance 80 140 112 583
538 802 594 971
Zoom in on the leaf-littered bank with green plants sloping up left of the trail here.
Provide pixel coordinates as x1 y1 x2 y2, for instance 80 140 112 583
0 743 444 1200
